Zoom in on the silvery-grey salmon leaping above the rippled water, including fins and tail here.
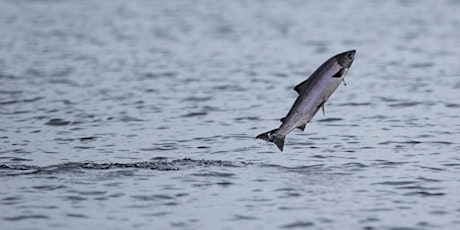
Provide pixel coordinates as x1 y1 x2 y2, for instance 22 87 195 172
257 50 356 151
